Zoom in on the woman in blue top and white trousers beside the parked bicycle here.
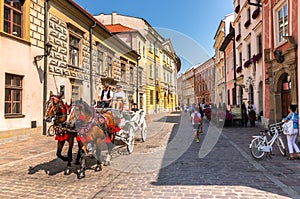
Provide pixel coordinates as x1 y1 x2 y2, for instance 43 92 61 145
282 104 300 160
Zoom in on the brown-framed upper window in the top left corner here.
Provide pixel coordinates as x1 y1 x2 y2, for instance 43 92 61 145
4 0 25 37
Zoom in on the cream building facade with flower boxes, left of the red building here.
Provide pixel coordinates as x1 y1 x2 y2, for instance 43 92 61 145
234 0 263 122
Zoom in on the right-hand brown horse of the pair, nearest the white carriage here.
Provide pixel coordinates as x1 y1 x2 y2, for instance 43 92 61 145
67 100 120 178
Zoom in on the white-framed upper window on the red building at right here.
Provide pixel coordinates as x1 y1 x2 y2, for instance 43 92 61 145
277 4 288 42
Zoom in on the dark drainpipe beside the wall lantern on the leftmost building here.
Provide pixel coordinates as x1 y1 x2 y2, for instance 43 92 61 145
43 0 49 135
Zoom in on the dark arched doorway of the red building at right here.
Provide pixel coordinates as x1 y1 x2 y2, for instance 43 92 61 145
281 73 292 117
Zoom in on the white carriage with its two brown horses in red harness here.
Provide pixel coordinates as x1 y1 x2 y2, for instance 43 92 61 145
45 91 147 178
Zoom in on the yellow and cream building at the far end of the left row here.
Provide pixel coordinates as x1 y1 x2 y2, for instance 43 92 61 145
95 12 180 114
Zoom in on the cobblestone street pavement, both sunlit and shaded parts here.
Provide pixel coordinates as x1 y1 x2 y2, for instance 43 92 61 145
0 112 300 198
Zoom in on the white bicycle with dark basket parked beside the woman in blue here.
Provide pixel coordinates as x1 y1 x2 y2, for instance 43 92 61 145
249 122 286 159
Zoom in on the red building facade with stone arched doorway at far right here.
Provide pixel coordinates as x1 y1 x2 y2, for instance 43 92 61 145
262 0 299 123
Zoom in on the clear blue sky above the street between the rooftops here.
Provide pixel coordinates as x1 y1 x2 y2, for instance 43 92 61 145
74 0 233 72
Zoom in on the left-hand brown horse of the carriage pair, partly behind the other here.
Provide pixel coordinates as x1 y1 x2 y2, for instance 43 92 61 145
44 92 81 175
